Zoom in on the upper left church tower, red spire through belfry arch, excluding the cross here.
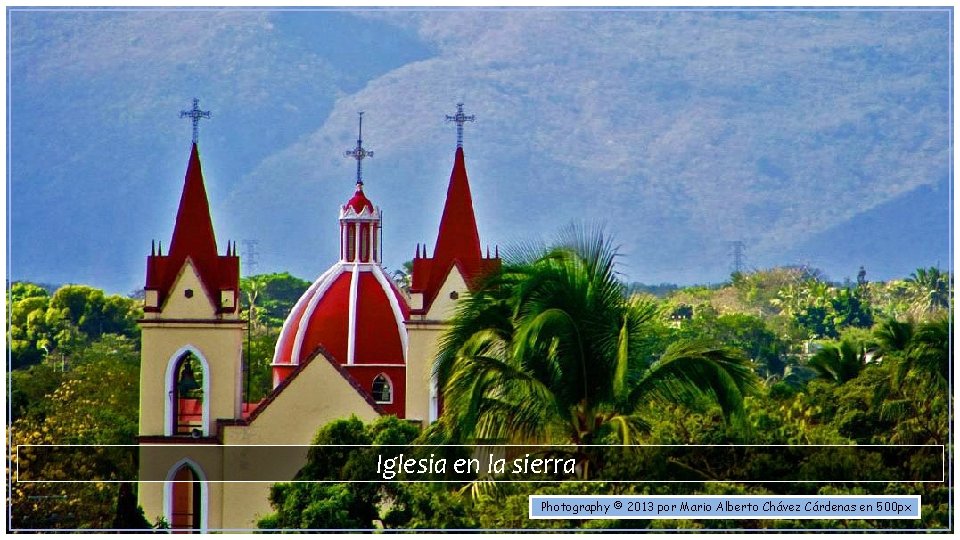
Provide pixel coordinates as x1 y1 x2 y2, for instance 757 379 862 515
140 125 244 437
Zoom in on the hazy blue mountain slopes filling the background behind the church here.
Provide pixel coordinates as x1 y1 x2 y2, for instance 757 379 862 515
7 8 952 293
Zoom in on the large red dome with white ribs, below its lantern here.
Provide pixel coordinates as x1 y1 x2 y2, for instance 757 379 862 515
273 262 409 366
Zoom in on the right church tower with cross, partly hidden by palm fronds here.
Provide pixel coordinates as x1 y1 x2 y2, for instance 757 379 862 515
406 103 500 423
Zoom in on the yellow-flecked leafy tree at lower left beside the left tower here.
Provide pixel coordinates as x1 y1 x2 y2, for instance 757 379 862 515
10 336 140 529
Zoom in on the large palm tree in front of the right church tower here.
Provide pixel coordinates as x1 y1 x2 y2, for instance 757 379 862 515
434 228 757 466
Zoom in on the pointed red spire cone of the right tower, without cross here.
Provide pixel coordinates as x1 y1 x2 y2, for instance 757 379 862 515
433 148 480 266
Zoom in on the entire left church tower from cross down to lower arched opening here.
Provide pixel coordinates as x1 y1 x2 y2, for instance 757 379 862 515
139 99 245 531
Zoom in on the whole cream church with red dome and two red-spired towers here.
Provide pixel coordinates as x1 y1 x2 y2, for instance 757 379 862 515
139 100 500 532
